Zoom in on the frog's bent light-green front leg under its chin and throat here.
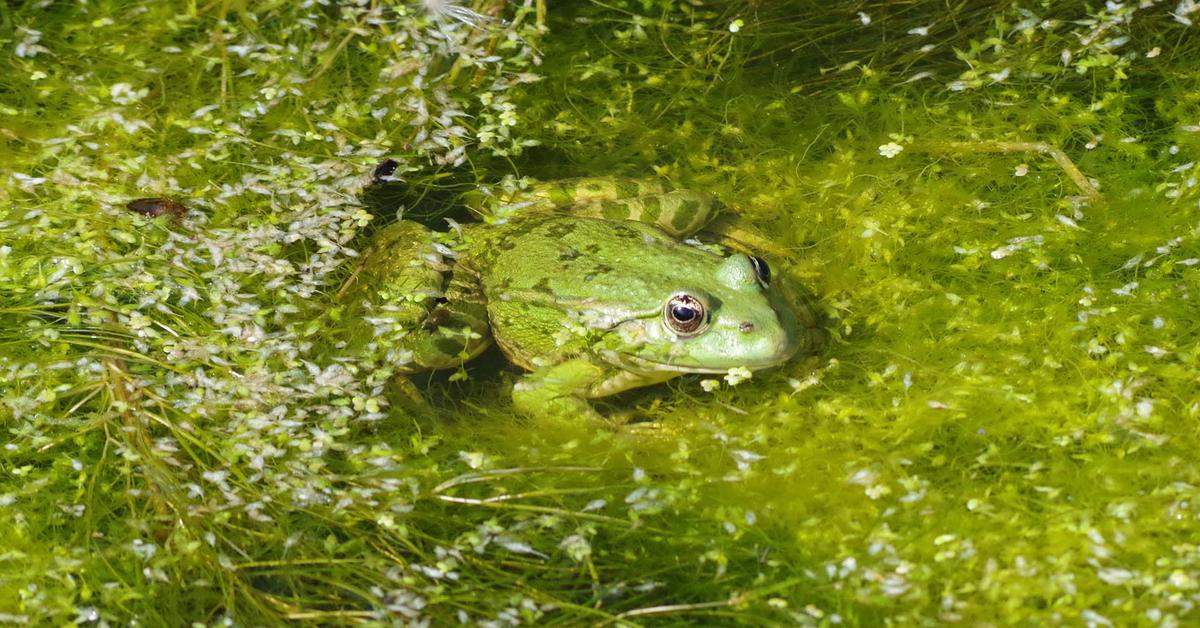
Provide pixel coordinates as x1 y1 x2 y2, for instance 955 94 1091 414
512 358 677 423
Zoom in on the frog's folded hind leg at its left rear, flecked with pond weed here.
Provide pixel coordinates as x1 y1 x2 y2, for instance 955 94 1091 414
338 221 491 372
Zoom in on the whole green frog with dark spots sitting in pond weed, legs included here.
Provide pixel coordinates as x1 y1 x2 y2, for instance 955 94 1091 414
343 178 820 419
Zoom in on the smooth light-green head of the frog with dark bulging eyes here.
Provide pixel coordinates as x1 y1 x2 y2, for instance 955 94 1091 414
610 255 804 373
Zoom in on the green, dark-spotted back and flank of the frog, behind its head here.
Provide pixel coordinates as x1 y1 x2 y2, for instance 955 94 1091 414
458 214 721 369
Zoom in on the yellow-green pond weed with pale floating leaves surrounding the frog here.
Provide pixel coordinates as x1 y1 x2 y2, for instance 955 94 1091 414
0 0 1200 626
